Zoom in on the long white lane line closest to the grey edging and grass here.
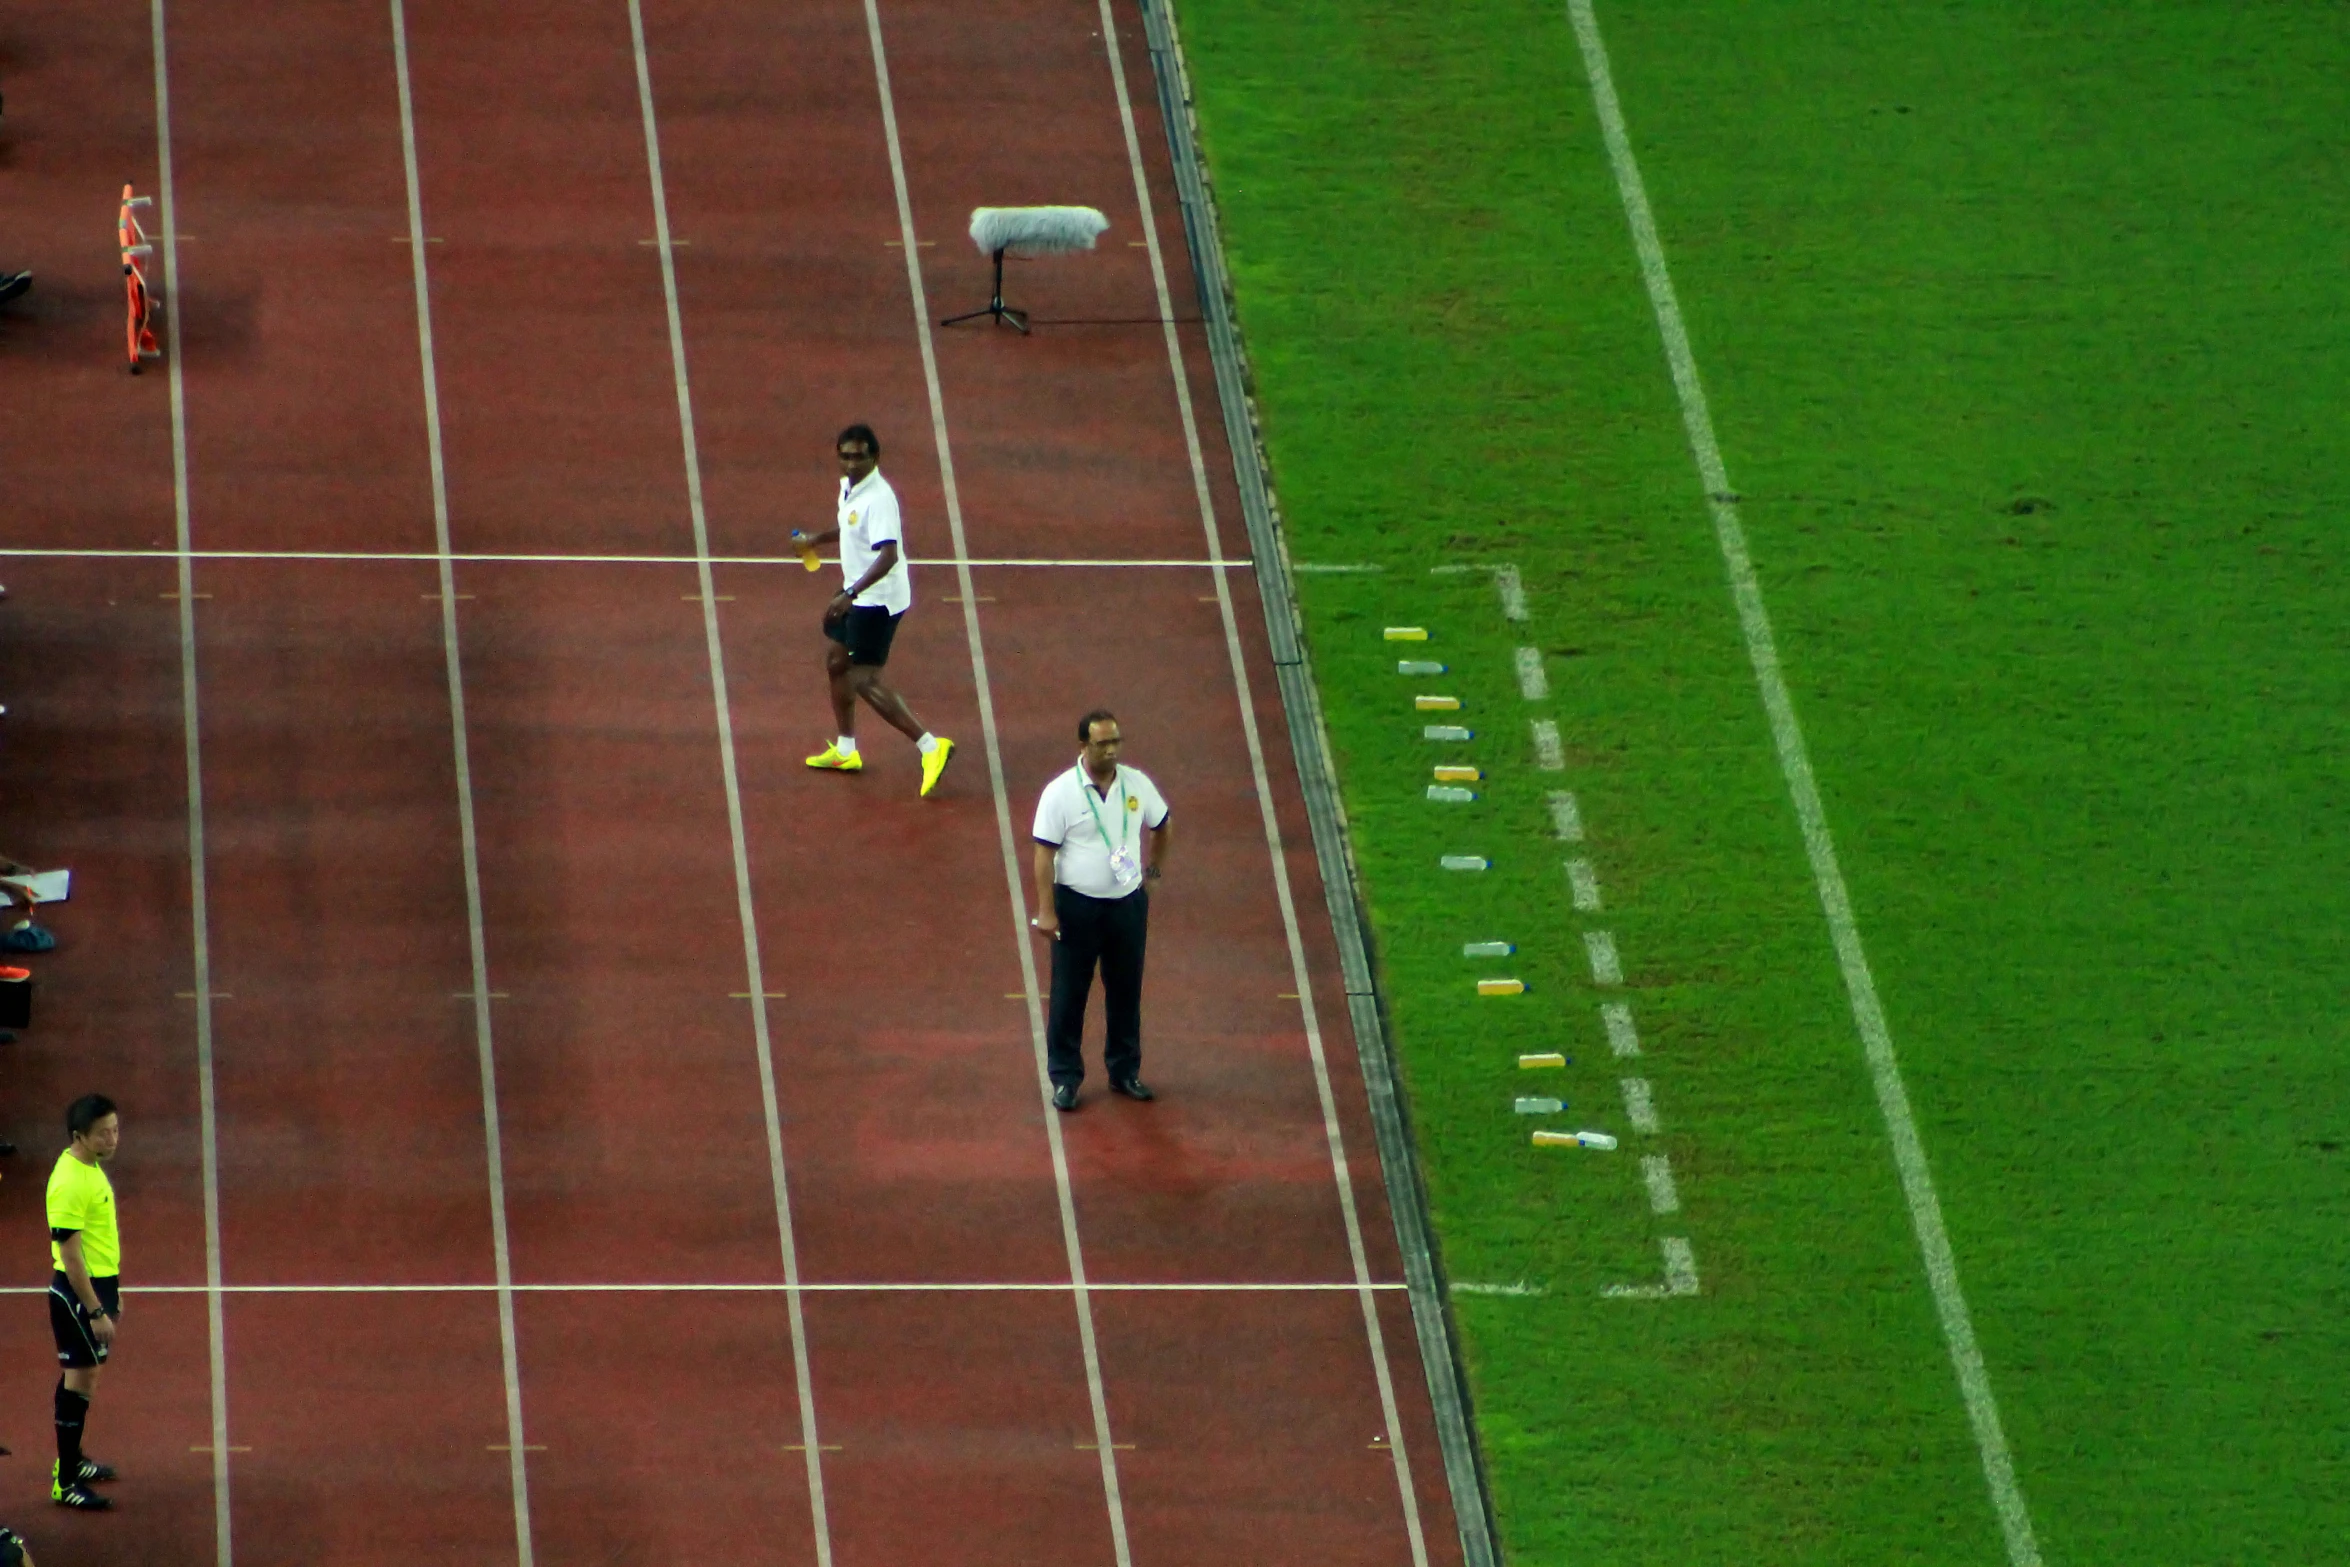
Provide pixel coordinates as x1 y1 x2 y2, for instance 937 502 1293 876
1100 0 1438 1567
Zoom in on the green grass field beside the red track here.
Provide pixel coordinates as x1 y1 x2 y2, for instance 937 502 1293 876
1180 0 2350 1567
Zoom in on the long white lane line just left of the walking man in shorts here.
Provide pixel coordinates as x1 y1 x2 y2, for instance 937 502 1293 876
625 0 832 1567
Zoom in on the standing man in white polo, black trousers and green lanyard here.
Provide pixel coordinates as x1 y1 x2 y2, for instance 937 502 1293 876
1029 707 1170 1109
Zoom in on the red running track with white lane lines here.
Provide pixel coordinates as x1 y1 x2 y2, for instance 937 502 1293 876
0 0 1457 1567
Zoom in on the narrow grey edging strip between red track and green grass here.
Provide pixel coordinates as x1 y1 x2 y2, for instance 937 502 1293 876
1135 0 1502 1567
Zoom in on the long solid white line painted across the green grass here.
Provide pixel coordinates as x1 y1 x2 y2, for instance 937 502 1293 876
1567 0 2040 1567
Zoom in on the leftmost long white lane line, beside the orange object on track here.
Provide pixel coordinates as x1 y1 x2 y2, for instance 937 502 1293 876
148 0 235 1567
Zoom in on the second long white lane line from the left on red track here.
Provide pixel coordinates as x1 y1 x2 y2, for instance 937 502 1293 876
390 0 533 1567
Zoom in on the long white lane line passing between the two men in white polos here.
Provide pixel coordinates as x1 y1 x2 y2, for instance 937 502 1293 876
865 0 1132 1567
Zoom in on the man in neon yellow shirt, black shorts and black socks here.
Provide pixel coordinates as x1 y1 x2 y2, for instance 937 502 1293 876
49 1095 122 1513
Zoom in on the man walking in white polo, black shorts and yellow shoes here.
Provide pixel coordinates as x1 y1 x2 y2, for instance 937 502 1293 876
792 425 954 794
